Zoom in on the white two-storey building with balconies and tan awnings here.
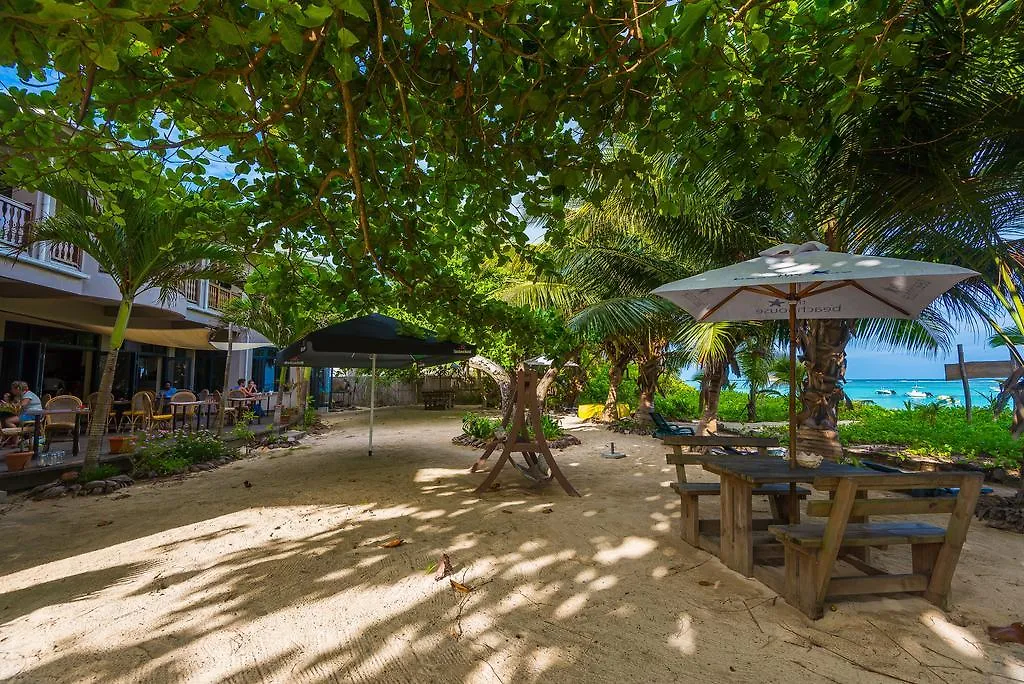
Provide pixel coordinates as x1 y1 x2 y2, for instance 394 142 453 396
0 188 273 398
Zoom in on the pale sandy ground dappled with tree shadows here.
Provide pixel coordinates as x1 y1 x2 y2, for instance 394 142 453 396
0 410 1024 683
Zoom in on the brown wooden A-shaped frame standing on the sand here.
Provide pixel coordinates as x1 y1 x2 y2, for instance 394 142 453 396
470 369 580 497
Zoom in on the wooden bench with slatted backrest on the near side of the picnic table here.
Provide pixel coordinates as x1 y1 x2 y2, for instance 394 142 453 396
768 473 982 619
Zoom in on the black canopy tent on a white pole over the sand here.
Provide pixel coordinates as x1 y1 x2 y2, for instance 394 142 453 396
278 313 476 456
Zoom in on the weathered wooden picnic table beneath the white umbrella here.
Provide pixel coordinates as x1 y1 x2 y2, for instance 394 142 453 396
695 455 870 578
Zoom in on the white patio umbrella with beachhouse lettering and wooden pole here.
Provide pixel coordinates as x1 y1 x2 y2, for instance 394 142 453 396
652 242 977 467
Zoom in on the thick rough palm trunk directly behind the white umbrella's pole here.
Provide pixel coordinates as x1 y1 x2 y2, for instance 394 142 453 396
797 318 852 459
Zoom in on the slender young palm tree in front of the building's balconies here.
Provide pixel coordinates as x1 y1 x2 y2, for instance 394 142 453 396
28 179 237 469
